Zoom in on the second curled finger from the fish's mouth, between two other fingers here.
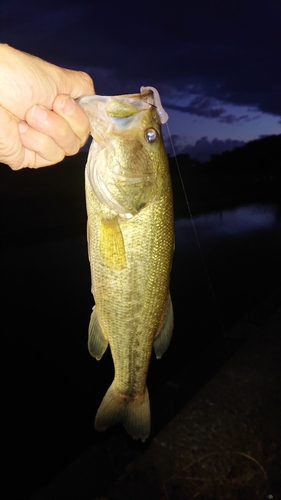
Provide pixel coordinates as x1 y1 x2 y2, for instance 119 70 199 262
26 105 81 156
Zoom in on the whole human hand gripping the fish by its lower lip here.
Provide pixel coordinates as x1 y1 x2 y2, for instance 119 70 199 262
0 44 94 170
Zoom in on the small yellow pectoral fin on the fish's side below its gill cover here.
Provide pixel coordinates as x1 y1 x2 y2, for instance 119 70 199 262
100 217 126 271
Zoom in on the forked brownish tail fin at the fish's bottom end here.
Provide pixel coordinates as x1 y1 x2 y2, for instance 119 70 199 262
95 383 150 441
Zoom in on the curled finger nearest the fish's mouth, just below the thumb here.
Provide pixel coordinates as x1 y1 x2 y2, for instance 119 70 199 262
53 94 90 146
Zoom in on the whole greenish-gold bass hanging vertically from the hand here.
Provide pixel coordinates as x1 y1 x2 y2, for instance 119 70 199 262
79 87 174 441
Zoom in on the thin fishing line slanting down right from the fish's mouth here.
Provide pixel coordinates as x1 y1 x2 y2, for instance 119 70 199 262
165 123 225 334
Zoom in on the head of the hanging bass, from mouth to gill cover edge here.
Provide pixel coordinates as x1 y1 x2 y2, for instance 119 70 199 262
79 90 166 218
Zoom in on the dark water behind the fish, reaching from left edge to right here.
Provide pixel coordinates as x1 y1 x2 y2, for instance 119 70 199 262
1 201 281 498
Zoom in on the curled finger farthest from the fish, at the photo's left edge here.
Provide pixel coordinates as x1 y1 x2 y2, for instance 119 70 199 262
0 106 24 170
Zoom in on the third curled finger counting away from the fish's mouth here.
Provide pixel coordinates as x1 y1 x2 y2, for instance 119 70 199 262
19 122 65 168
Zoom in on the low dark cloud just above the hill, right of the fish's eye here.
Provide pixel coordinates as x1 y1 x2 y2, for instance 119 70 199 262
165 135 245 162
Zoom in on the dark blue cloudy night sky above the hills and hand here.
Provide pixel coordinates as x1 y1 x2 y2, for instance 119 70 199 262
0 0 281 160
